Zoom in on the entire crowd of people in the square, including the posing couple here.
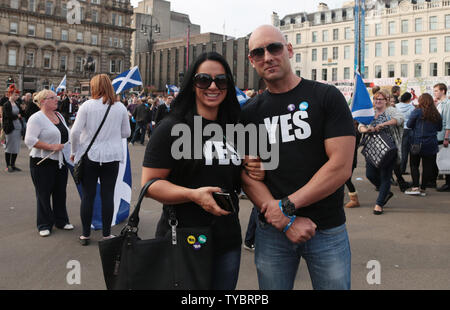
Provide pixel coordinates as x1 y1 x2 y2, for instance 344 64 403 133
2 25 450 290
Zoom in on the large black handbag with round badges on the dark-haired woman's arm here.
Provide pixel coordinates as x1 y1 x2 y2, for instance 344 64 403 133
99 179 213 290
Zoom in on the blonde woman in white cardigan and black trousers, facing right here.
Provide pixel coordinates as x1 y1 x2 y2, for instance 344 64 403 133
25 89 73 237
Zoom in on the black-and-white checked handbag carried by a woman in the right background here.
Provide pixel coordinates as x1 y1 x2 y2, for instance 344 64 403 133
361 131 397 168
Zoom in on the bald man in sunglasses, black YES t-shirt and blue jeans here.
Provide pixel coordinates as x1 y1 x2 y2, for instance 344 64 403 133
242 26 355 289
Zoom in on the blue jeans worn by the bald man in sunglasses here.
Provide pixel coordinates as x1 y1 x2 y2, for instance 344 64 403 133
255 219 351 290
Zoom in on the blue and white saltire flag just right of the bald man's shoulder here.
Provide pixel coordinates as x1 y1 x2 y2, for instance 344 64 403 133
351 72 375 125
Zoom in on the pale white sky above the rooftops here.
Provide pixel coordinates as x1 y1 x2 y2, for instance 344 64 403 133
131 0 344 37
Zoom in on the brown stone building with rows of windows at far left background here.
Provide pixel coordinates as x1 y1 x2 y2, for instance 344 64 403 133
0 0 133 94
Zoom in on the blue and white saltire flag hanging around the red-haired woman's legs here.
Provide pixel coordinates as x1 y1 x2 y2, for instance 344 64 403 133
63 139 131 230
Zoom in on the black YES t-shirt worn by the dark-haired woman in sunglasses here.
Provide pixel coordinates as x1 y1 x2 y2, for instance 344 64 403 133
143 116 242 253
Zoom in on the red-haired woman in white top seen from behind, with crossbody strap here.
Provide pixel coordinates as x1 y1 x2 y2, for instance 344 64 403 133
70 74 131 245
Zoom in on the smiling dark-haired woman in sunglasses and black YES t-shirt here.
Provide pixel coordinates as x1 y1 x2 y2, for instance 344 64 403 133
142 52 262 290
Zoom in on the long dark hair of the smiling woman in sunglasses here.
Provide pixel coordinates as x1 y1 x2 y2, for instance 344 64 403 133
171 52 241 126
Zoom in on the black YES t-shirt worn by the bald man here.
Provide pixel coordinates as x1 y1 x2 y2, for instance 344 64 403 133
241 79 355 229
